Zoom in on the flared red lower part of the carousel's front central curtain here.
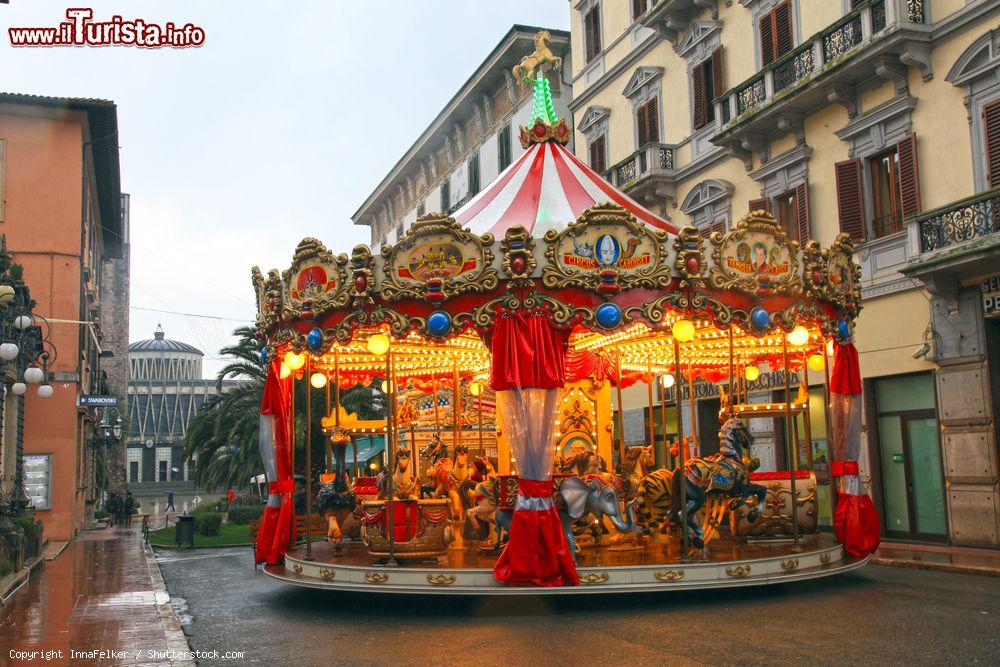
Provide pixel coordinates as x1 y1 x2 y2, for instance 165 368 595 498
493 479 580 586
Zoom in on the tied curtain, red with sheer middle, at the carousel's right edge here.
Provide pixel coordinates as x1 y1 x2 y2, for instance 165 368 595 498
830 341 881 558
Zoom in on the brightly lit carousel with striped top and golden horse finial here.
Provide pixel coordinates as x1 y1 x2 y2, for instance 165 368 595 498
253 45 879 594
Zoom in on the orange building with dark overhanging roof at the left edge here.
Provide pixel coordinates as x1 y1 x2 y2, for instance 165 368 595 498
0 93 128 540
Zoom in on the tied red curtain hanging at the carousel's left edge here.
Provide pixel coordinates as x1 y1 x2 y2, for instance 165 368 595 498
255 360 295 565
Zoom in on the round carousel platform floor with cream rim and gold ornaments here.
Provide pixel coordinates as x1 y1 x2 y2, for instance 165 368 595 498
264 534 868 595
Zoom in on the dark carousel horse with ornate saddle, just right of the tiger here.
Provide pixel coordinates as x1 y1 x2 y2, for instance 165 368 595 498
670 417 767 549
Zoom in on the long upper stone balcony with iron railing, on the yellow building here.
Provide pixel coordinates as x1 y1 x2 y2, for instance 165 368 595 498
712 0 931 160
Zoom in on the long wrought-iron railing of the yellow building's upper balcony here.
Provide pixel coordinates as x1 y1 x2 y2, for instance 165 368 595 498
715 0 925 126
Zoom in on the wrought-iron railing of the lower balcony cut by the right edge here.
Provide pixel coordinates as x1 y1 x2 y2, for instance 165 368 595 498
916 188 1000 252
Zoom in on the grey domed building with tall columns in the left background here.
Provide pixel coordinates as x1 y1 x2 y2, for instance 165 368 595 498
123 327 238 486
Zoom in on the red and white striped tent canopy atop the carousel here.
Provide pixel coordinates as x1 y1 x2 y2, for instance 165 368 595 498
454 141 677 238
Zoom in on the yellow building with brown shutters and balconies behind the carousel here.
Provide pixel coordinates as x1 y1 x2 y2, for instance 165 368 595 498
569 0 1000 547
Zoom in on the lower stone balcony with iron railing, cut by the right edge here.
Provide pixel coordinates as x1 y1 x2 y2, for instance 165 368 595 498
902 188 1000 308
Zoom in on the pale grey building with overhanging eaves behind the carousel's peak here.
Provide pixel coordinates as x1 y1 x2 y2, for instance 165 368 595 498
351 25 571 251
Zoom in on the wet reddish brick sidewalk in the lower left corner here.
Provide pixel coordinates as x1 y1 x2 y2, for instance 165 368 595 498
0 527 193 665
